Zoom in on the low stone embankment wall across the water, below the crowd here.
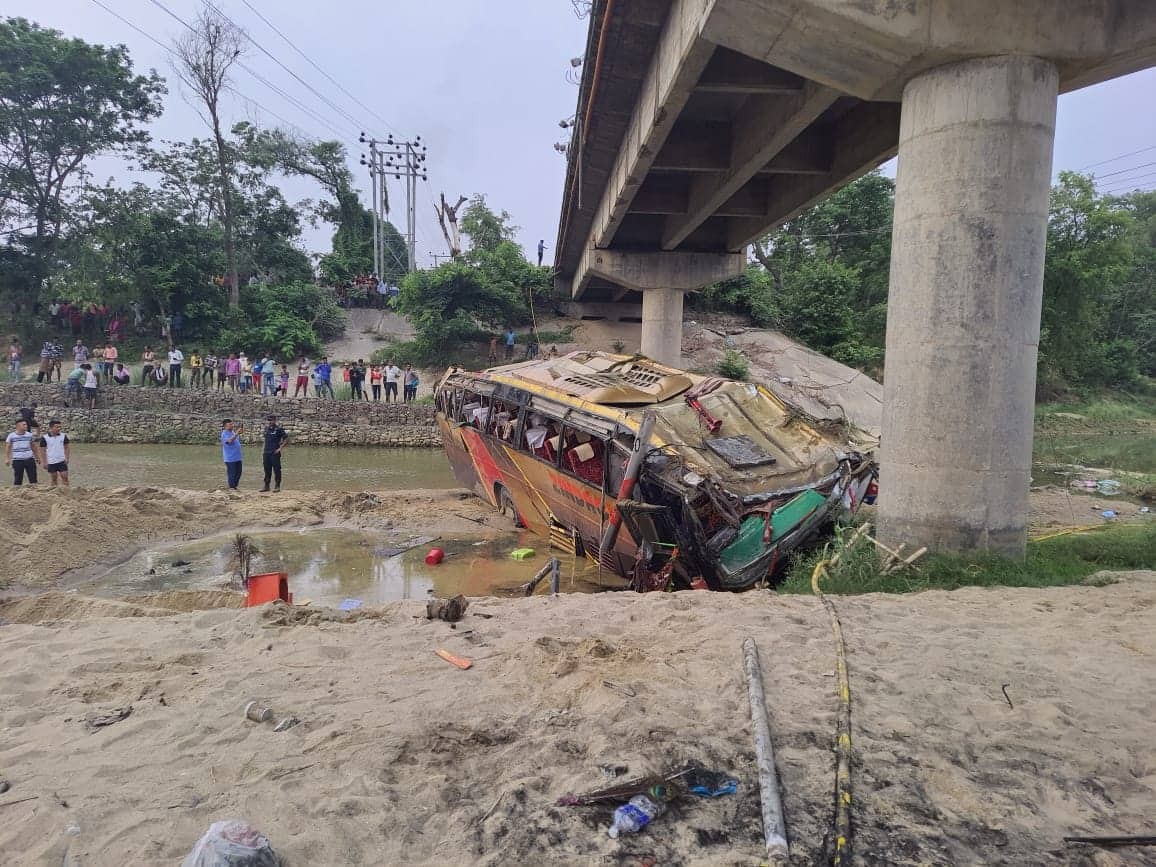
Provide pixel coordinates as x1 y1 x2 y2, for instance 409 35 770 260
0 383 442 447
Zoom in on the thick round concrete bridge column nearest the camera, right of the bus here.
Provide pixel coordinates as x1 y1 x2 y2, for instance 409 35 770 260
879 55 1058 556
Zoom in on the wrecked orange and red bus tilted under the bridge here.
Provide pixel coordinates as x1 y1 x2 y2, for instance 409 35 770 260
436 351 877 591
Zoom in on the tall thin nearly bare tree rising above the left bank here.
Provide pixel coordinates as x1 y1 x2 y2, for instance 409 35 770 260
173 5 246 307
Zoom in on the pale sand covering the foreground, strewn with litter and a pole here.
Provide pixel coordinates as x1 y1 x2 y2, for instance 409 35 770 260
0 573 1156 867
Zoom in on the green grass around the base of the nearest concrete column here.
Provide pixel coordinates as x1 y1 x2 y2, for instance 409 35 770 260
778 521 1156 594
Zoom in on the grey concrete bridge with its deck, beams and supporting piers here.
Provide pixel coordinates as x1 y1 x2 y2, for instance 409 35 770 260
555 0 1156 555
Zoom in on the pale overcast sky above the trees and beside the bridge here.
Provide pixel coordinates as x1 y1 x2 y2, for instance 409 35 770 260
3 0 1156 265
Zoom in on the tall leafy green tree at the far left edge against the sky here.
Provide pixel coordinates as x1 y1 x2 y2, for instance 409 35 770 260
0 18 165 307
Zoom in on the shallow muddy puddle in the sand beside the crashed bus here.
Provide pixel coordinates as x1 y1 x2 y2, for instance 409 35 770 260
77 527 623 607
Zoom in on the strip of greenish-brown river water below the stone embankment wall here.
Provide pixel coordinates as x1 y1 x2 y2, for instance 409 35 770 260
69 443 458 490
